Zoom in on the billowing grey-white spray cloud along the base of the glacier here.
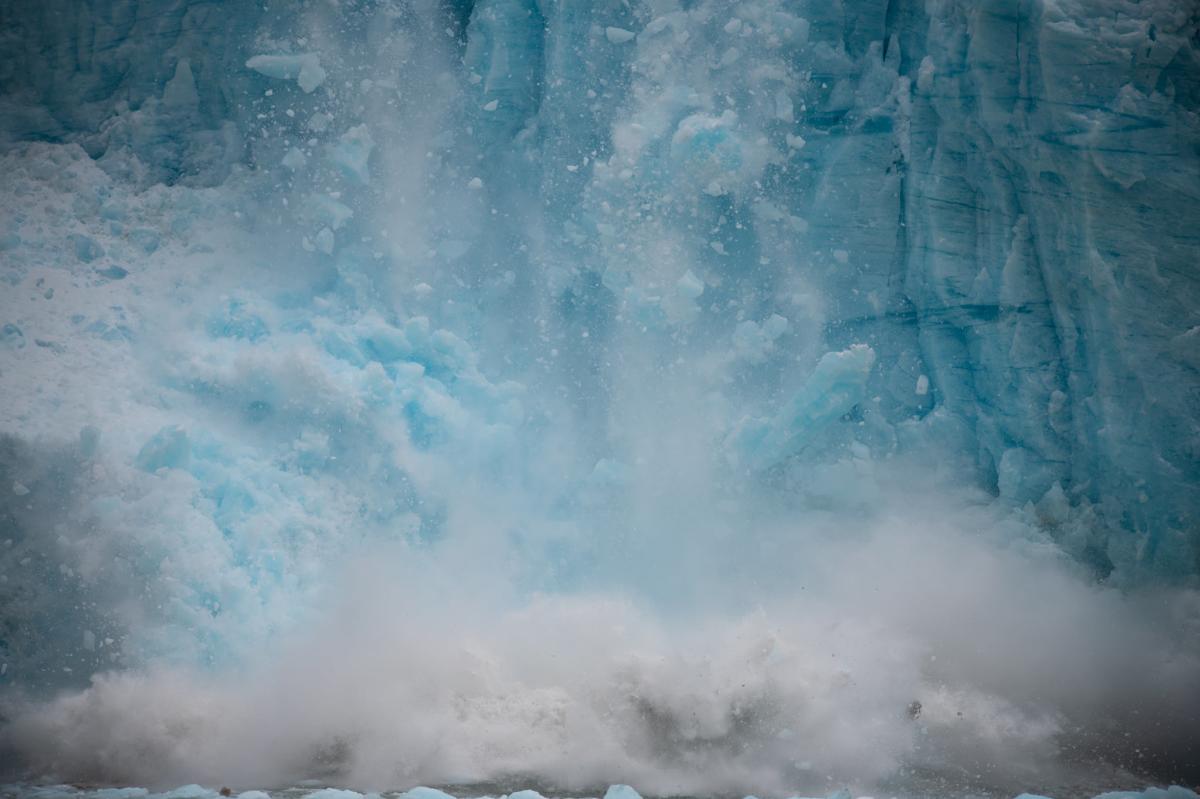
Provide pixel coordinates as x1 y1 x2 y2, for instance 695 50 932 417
10 475 1200 795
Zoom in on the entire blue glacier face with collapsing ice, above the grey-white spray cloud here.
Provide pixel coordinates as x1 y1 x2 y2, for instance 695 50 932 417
0 0 1200 791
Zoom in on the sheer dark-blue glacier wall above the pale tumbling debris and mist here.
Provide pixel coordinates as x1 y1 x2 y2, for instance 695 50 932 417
4 1 1198 577
